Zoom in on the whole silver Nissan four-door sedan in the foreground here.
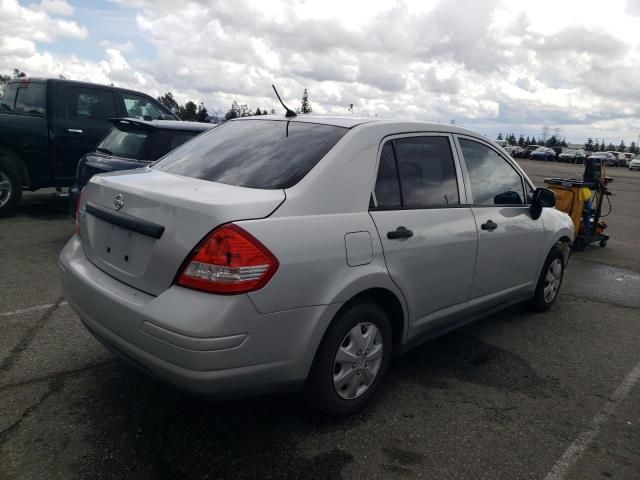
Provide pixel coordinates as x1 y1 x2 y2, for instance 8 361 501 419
60 115 573 415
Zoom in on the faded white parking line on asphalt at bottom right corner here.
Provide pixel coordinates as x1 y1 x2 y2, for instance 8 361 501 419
544 362 640 480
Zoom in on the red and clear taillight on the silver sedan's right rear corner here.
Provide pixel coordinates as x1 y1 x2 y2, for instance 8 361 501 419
176 224 278 294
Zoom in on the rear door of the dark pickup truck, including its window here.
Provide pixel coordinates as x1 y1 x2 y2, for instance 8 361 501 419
53 83 117 186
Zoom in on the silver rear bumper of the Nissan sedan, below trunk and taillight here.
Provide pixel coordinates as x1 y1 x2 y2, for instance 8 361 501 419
59 236 340 397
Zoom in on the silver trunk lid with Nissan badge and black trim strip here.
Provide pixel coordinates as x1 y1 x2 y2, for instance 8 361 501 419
80 168 285 295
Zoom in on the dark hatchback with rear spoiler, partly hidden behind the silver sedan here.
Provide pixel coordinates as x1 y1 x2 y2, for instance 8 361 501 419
69 118 216 217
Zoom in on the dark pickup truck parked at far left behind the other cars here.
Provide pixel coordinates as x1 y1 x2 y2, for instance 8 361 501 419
0 78 178 217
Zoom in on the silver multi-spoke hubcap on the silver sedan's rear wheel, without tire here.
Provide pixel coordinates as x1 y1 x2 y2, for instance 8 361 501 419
333 322 383 400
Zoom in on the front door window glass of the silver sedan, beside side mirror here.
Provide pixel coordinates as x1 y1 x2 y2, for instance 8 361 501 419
460 138 525 205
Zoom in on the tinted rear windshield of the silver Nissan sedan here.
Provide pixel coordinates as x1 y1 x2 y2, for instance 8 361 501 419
153 120 348 189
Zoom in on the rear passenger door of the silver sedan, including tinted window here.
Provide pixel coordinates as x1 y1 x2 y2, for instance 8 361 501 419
370 134 477 336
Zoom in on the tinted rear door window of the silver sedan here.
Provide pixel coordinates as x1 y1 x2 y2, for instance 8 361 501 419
375 136 460 208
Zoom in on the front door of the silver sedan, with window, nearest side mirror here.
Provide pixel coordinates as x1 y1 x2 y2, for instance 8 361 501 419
457 136 544 304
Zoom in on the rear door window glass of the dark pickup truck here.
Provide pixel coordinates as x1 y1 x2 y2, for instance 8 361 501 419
60 87 116 121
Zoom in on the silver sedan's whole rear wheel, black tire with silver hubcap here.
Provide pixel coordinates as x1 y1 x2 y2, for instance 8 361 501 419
305 302 392 417
